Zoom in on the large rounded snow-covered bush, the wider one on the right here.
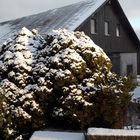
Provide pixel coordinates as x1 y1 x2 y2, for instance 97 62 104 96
43 29 134 129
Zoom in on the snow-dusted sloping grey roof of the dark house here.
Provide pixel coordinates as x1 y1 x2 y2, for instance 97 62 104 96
0 0 106 44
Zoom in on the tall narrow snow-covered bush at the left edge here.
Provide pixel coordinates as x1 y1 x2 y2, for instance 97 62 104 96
0 28 45 139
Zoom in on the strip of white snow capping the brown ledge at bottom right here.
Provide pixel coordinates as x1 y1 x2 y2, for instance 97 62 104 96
87 128 140 136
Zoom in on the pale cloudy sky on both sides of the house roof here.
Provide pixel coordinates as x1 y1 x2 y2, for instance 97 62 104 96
0 0 140 38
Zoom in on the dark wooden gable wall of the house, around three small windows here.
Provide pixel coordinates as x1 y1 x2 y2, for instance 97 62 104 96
76 3 140 74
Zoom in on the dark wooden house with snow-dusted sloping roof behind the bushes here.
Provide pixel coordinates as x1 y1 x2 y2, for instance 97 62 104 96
0 0 140 76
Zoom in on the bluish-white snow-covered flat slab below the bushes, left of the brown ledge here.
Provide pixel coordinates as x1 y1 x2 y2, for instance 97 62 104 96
30 131 85 140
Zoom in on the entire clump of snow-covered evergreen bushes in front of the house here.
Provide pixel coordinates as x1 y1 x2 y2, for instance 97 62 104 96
0 28 134 139
